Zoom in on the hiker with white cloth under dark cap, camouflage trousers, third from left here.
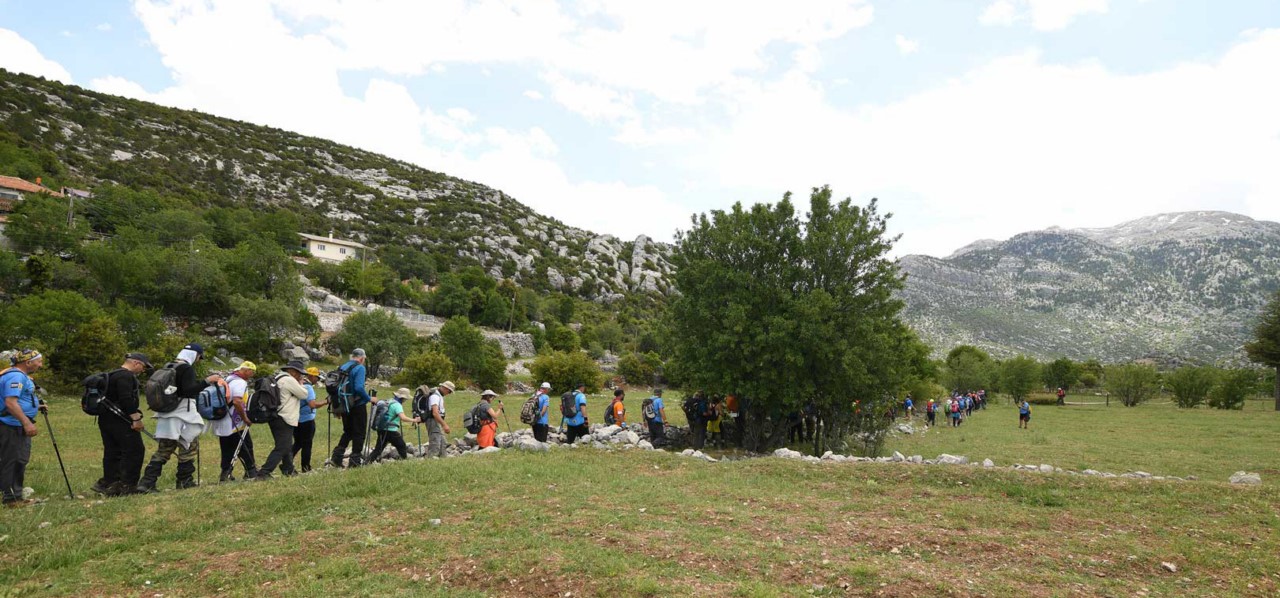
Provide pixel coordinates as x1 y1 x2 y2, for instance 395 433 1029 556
138 343 227 493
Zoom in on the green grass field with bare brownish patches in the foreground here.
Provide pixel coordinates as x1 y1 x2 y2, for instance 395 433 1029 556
0 393 1280 597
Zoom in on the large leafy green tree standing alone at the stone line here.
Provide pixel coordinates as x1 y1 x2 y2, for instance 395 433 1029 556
667 187 928 452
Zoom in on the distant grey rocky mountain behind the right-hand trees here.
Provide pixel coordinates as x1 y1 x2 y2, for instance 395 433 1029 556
900 211 1280 361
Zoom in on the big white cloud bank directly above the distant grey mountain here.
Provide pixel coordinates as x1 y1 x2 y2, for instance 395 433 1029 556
699 29 1280 254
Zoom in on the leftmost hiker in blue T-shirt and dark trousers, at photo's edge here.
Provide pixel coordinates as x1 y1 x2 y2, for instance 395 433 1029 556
0 348 49 507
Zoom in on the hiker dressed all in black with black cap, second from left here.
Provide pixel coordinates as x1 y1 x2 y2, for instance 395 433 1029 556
91 353 151 497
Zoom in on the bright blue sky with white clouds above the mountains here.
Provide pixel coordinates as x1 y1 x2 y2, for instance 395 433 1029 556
0 0 1280 256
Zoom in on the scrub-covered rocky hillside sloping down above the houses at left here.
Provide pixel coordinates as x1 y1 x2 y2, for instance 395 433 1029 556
0 69 671 301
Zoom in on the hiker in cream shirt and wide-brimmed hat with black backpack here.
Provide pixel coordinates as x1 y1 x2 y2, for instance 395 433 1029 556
248 361 307 480
